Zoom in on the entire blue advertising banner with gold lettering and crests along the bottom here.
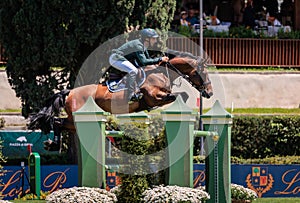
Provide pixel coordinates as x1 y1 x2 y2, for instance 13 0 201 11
0 164 300 199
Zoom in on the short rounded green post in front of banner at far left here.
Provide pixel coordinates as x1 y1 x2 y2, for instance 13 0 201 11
28 152 41 199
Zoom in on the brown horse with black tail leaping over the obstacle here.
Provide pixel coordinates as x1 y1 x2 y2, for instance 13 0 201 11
27 56 213 151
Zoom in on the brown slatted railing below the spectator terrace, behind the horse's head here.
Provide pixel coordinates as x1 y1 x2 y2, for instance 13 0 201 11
167 37 300 68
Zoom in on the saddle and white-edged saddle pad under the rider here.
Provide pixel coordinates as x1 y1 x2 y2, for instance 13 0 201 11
104 67 146 92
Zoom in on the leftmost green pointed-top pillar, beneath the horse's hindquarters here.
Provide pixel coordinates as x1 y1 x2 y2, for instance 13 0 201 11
73 97 109 188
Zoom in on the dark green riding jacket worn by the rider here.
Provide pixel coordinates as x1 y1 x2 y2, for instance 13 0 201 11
112 39 162 66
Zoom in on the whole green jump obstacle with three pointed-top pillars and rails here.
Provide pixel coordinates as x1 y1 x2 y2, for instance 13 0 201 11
73 96 232 203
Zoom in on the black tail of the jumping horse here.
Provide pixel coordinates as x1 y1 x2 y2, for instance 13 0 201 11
27 90 70 134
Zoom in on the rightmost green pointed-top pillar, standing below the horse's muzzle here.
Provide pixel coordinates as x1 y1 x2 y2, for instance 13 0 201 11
201 100 232 203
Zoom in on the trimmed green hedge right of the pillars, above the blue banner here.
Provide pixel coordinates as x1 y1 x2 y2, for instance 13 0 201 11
231 116 300 159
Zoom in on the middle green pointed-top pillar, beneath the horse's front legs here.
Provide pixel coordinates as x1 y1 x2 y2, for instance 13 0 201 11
161 96 196 187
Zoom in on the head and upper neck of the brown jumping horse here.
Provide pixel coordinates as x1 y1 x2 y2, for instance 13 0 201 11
169 57 213 98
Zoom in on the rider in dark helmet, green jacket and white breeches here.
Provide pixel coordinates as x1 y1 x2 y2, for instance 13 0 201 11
109 28 169 103
